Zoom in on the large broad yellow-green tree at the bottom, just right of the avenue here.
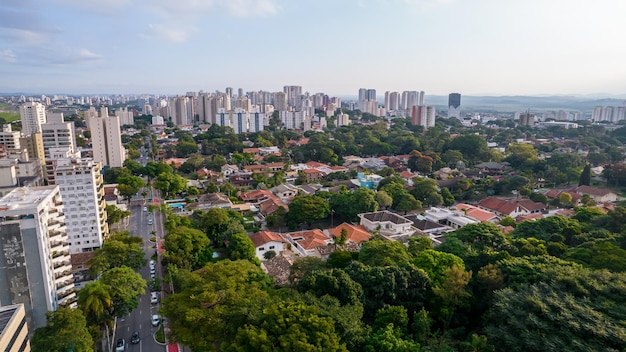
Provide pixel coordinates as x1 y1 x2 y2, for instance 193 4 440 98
161 260 272 351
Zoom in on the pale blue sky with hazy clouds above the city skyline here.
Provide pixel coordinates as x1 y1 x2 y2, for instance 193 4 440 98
0 0 626 96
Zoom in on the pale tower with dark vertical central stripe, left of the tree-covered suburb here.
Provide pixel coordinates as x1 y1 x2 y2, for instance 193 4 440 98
87 115 126 167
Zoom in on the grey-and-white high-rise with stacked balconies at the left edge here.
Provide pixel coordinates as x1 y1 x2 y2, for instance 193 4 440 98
0 186 76 331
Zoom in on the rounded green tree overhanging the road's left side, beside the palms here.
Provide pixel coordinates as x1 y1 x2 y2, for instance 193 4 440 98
100 266 147 318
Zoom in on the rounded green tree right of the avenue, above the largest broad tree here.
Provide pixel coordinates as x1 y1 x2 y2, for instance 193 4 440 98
163 227 213 270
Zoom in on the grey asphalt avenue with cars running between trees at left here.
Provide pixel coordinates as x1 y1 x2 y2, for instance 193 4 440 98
113 189 166 352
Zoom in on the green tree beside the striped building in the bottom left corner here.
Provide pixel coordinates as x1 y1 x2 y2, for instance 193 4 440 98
31 307 94 352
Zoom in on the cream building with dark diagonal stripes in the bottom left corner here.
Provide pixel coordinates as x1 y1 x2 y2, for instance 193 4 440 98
0 304 30 352
